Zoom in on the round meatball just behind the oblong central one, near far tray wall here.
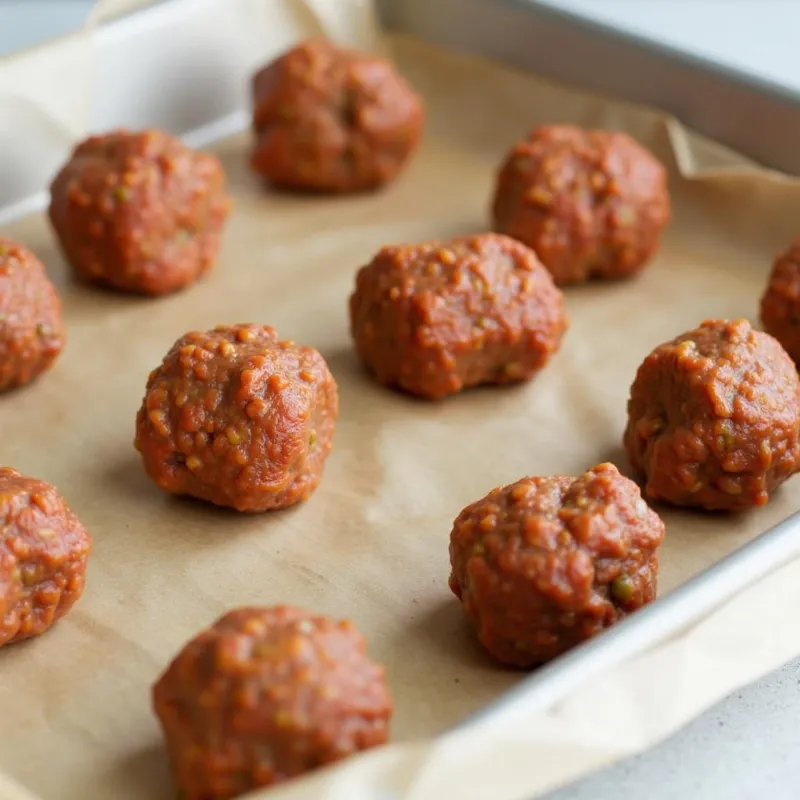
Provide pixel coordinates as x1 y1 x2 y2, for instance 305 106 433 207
492 125 671 285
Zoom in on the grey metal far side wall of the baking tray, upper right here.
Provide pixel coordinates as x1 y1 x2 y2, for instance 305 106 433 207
378 0 800 174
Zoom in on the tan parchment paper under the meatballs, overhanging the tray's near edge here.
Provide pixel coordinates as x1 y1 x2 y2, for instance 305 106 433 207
0 4 800 800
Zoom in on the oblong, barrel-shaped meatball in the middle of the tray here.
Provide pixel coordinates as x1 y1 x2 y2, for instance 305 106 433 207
350 234 568 399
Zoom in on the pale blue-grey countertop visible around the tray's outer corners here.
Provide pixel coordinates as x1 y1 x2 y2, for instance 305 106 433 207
0 0 800 800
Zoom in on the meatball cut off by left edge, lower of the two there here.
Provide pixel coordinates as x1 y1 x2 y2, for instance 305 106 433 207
0 467 92 645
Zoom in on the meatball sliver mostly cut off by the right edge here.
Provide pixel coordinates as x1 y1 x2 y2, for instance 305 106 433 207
761 239 800 364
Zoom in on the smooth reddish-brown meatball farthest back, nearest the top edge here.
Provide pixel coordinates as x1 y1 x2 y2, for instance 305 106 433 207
251 39 424 192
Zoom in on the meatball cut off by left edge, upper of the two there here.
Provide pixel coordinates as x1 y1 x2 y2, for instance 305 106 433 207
0 238 65 392
